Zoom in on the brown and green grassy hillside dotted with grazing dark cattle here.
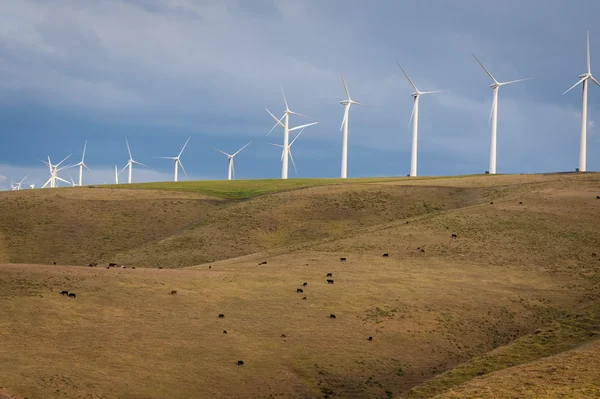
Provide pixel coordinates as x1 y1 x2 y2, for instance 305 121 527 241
0 174 600 398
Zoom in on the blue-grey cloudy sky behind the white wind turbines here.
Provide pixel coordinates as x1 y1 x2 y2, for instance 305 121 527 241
0 0 600 189
